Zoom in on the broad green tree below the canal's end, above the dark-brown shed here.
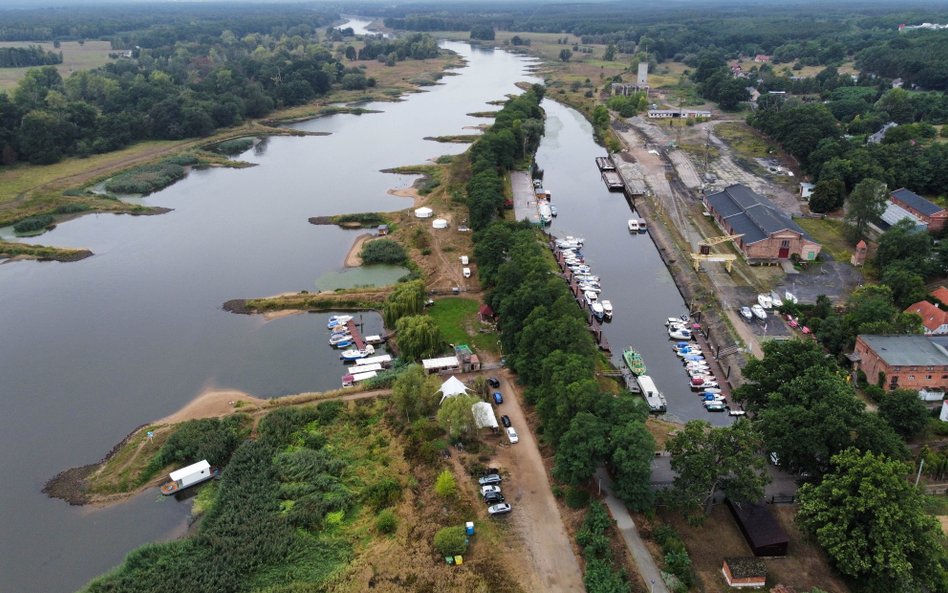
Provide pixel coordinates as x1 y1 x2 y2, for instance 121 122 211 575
667 419 769 514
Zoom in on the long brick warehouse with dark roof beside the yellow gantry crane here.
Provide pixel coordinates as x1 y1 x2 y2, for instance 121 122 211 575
704 185 821 263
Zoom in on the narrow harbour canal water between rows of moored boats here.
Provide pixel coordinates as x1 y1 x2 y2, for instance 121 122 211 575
536 99 731 425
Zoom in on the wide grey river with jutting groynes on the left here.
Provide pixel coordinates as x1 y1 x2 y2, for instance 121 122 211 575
0 22 534 593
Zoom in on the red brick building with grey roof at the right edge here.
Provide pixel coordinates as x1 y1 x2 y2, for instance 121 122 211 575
854 335 948 390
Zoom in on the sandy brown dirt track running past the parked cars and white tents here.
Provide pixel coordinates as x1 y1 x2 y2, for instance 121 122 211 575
491 370 585 592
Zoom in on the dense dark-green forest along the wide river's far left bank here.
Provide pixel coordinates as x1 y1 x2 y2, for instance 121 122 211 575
0 19 437 165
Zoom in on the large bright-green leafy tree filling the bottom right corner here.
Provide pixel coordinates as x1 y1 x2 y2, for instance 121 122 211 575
797 449 948 593
